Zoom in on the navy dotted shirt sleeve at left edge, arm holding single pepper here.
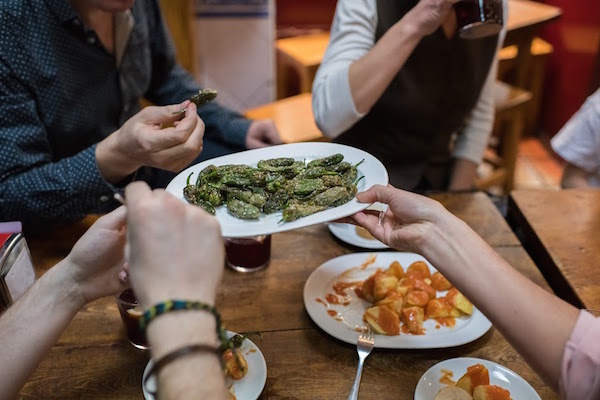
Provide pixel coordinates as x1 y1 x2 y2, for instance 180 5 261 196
0 60 122 231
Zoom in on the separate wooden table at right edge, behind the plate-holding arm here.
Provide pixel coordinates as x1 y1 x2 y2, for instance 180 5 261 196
508 189 600 310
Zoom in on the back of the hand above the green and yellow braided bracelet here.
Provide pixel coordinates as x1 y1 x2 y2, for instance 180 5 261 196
125 182 225 307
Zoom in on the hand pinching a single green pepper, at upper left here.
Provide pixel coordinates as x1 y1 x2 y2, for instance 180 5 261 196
96 100 204 183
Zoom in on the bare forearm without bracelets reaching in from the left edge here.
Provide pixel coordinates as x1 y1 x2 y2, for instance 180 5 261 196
0 261 83 399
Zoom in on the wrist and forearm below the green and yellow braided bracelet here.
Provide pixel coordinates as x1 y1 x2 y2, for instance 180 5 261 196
147 311 227 400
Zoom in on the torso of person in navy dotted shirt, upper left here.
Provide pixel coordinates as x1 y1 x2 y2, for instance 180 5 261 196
2 0 157 159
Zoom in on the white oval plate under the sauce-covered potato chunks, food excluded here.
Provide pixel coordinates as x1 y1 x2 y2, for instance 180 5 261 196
304 252 492 349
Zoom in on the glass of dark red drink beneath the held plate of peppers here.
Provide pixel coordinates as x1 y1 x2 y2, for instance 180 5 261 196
224 235 271 272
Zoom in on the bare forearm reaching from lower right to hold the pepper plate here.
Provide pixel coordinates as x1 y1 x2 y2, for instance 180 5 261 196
422 214 578 388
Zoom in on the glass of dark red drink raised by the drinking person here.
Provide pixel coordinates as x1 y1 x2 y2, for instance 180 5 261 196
454 0 503 39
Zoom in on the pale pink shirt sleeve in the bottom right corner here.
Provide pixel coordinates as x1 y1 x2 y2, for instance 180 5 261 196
559 310 600 400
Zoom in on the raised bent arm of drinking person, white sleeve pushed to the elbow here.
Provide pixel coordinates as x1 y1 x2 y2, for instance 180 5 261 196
313 0 457 137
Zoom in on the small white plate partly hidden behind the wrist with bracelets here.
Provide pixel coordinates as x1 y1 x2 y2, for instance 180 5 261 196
142 331 267 400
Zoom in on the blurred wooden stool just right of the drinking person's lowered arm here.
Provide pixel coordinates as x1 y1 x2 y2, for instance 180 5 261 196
475 81 532 193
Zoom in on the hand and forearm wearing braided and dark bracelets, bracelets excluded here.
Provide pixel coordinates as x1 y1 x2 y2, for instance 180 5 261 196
126 182 227 399
